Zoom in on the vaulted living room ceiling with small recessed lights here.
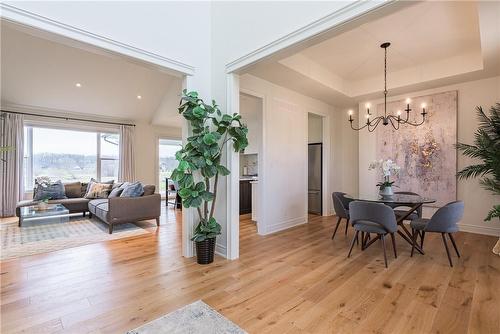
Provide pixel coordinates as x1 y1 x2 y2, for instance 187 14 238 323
1 21 181 127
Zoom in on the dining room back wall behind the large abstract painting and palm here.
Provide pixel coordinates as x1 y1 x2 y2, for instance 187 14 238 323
359 77 500 235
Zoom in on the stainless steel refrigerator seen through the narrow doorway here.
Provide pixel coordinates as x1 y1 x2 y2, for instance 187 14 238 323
307 144 323 215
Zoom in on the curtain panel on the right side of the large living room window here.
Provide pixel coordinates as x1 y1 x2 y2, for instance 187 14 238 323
118 125 135 182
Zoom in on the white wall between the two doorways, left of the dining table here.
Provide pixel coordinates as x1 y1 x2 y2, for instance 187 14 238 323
240 74 332 234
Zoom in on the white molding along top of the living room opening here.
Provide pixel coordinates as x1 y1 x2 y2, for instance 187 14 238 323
0 2 195 75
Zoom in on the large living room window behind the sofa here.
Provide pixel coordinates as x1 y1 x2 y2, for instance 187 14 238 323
24 126 119 190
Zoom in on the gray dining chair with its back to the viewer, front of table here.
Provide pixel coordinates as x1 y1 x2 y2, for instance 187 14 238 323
347 201 398 268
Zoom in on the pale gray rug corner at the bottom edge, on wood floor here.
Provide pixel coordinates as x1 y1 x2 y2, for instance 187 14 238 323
127 300 246 334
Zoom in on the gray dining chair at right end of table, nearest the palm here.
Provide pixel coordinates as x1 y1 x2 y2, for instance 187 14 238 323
410 201 464 267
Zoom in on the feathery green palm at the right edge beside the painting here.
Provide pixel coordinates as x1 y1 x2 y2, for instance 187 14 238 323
456 103 500 255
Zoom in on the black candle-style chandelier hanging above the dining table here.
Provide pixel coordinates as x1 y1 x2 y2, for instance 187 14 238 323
349 42 427 132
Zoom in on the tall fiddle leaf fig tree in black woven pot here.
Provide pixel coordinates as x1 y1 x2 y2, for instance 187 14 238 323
171 90 248 264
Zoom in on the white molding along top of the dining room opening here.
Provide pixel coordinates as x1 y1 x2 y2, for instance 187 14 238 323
226 0 397 73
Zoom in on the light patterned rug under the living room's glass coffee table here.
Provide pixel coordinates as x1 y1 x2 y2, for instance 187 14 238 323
0 217 155 260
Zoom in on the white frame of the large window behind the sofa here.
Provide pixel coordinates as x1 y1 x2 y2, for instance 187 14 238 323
23 121 120 193
